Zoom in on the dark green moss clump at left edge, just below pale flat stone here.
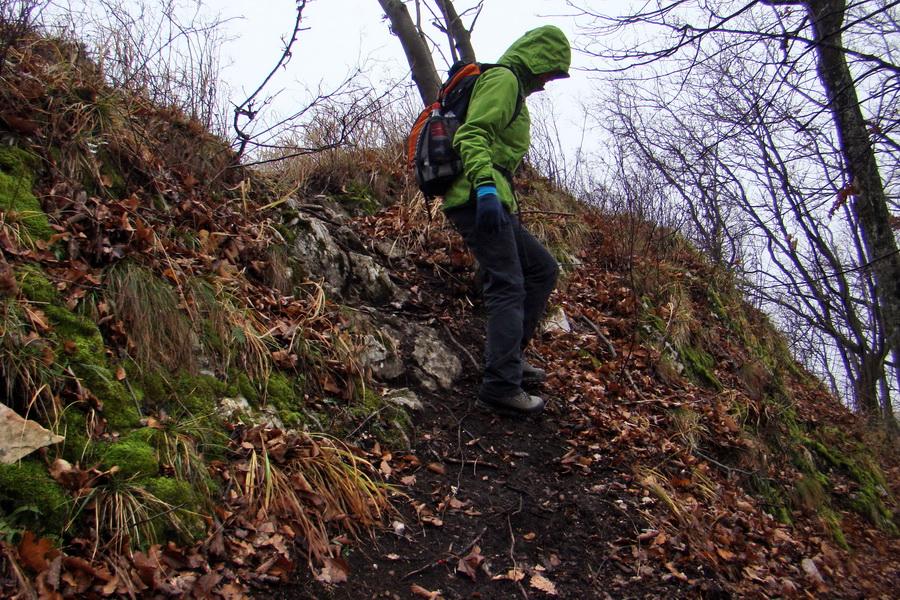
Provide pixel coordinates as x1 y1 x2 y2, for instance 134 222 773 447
0 459 69 535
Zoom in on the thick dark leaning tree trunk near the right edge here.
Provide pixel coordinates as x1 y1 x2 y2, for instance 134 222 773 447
805 0 900 416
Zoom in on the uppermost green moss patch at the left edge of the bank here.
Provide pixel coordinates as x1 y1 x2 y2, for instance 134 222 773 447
0 146 53 242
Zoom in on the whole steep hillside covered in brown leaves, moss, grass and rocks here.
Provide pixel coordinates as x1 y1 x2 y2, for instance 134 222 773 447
0 25 900 598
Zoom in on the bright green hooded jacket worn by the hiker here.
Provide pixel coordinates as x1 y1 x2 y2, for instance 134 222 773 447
443 25 572 212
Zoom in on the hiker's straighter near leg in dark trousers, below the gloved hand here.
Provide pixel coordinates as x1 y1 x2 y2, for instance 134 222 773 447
446 204 526 397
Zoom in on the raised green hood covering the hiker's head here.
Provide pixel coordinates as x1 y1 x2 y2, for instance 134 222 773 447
497 25 572 92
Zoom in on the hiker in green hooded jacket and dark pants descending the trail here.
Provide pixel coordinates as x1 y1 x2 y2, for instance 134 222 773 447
442 25 571 414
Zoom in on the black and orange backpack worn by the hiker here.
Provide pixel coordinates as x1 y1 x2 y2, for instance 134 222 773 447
407 62 524 197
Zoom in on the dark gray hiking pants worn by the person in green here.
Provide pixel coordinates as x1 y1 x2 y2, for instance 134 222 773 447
446 202 559 396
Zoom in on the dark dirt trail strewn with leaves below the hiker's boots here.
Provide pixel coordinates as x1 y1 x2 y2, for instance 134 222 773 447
277 354 692 600
